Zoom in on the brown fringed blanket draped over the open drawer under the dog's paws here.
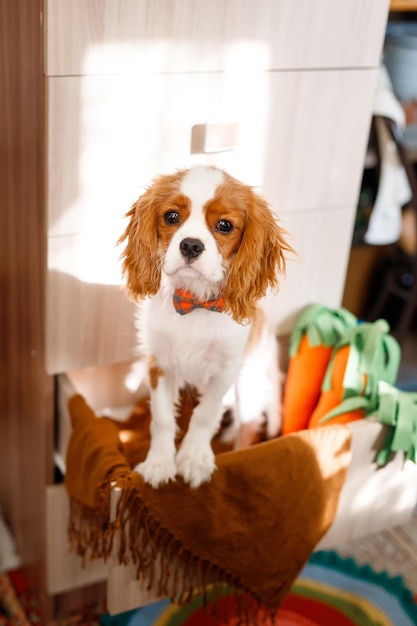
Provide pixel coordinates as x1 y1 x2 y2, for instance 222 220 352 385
66 396 351 609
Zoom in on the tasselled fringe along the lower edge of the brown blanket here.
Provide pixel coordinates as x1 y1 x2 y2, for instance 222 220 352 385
68 475 278 626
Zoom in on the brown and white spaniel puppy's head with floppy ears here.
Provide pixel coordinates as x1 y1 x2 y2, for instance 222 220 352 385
120 167 291 322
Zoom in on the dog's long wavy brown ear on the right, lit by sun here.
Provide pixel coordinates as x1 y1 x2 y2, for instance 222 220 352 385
223 190 294 323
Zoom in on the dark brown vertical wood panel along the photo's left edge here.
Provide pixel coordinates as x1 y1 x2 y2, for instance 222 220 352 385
0 0 53 616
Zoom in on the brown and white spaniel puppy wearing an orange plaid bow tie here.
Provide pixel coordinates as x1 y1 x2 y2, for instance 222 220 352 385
119 166 291 488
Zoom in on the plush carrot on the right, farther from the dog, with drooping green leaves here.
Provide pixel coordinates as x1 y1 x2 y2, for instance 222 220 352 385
309 320 400 428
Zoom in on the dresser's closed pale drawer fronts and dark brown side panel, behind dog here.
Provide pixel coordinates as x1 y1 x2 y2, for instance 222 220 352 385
0 0 389 613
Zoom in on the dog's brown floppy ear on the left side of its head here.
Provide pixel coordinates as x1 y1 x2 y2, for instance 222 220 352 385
118 189 161 300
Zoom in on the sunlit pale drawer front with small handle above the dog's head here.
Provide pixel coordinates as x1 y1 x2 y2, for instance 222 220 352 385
47 70 377 236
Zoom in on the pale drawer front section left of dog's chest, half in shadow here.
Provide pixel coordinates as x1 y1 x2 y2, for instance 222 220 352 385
45 234 136 374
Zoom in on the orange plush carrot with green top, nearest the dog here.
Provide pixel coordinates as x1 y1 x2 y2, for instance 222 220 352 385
282 304 357 435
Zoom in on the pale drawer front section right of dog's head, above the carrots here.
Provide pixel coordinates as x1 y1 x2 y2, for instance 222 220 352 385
265 206 356 335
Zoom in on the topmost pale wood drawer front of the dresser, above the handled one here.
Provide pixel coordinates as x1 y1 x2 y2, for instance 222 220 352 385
46 0 389 76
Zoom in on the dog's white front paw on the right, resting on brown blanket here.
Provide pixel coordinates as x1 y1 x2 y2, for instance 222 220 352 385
176 438 216 488
